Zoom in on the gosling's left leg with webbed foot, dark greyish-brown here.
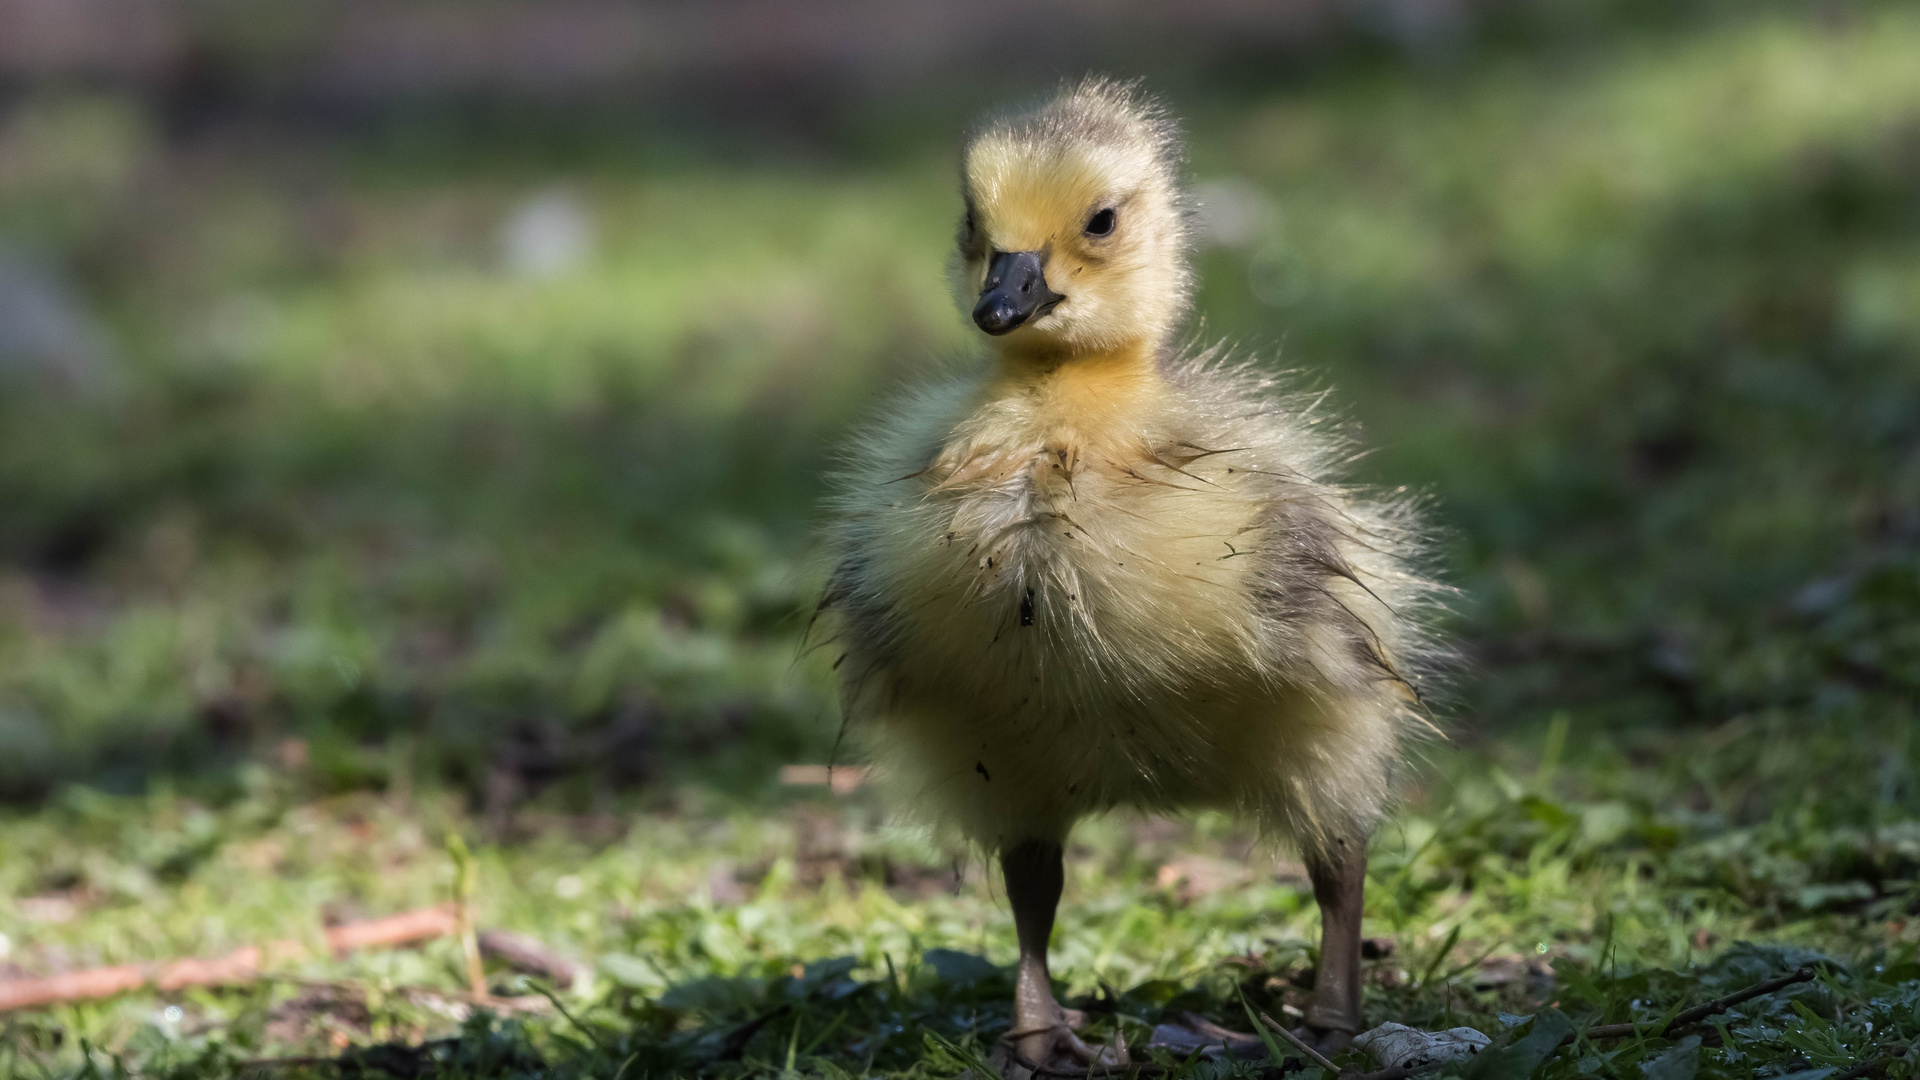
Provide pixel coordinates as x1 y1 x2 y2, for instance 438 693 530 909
1000 840 1127 1067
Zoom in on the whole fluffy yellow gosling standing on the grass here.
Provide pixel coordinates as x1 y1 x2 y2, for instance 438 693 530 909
822 79 1438 1067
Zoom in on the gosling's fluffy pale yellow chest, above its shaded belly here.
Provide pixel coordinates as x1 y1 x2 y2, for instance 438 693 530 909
876 428 1265 686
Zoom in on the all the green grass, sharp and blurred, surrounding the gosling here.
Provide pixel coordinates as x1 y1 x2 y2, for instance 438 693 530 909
0 4 1920 1078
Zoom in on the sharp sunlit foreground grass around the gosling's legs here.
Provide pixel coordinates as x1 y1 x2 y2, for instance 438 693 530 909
8 753 1920 1076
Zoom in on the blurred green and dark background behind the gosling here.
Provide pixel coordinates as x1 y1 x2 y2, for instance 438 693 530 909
0 0 1920 1068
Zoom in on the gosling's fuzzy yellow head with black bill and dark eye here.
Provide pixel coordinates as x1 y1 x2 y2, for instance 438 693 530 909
960 79 1190 356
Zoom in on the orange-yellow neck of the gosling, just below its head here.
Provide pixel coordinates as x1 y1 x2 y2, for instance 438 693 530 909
987 342 1164 436
